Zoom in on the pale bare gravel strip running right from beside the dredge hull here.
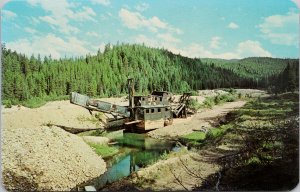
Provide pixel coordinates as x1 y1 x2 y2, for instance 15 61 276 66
148 101 246 138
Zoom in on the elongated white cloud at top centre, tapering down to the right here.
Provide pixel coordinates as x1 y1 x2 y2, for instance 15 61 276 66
119 8 182 34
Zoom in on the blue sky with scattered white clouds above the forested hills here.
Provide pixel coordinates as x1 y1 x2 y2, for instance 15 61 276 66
1 0 299 59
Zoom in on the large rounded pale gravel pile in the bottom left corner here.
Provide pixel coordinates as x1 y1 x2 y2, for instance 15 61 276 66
2 126 106 191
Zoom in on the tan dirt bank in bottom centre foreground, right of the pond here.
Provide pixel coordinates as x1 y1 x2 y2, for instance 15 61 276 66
132 152 220 191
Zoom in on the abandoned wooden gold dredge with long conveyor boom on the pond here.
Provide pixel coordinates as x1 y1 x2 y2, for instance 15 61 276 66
70 78 191 131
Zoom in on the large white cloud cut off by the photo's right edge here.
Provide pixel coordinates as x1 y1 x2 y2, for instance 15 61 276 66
258 12 299 46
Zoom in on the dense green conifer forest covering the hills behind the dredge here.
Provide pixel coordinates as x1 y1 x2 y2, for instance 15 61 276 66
2 44 298 103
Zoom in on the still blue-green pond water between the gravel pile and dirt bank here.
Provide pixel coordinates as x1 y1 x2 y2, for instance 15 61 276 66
92 133 179 189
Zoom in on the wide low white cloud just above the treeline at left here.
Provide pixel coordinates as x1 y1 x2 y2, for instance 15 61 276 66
6 34 94 59
